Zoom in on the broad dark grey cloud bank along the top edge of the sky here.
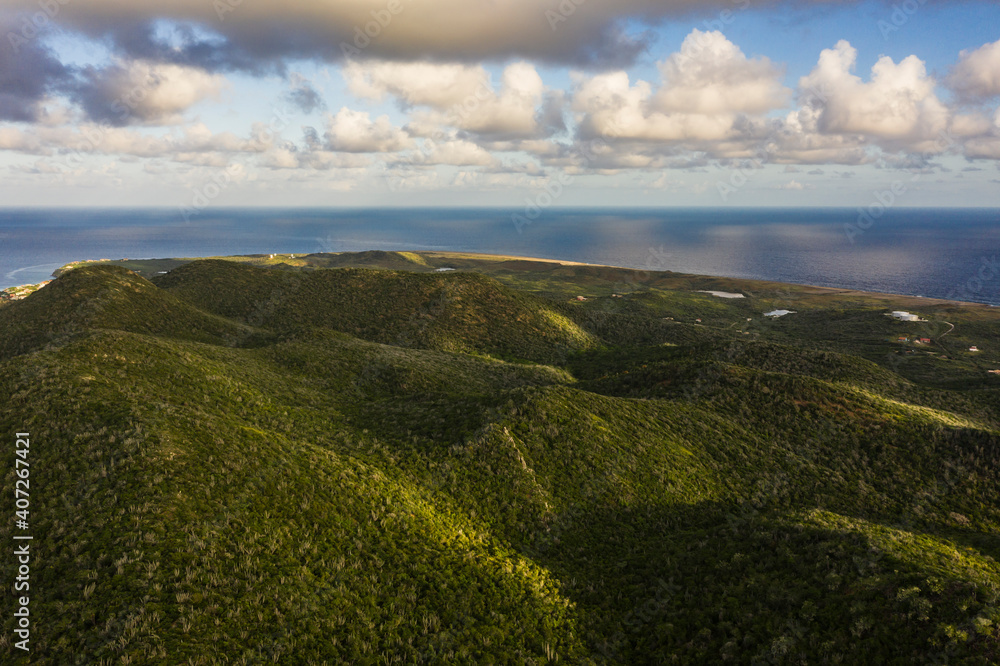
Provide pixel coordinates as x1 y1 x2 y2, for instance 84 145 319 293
25 0 960 74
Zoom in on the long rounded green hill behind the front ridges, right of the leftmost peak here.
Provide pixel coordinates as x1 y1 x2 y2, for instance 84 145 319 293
156 261 595 361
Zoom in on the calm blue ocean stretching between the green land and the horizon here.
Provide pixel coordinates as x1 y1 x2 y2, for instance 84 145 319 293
0 208 1000 305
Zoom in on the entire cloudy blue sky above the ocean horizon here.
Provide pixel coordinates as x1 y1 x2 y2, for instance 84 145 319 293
0 0 1000 208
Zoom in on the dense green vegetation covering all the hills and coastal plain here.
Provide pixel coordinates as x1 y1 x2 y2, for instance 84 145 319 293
0 253 1000 665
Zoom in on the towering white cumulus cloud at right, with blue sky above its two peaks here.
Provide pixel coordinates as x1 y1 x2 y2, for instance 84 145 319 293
799 40 949 152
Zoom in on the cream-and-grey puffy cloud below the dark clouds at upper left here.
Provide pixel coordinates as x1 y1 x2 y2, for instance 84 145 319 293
73 61 225 126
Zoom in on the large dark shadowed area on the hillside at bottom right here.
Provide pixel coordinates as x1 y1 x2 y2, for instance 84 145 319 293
529 503 998 664
